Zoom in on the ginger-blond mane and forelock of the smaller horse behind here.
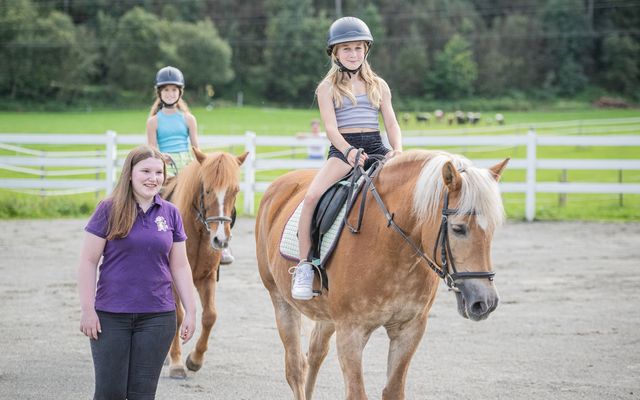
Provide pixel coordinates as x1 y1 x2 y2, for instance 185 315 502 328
174 152 240 210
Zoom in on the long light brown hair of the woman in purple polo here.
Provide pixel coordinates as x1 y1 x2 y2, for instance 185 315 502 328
106 145 167 240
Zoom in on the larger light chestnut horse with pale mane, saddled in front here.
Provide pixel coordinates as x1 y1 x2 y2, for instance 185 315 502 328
256 150 508 400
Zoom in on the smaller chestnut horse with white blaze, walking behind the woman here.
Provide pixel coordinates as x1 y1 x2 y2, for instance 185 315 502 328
166 148 248 378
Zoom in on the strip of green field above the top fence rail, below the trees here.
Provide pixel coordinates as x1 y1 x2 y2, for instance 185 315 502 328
0 106 640 135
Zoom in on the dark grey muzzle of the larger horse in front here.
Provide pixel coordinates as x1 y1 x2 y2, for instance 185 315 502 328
455 279 500 321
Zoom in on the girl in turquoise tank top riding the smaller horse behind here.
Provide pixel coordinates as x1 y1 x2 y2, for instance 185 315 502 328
147 66 234 264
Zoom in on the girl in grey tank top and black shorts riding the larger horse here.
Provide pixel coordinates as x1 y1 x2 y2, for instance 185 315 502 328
291 17 402 300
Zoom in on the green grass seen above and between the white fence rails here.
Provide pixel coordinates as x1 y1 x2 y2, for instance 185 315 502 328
0 107 640 221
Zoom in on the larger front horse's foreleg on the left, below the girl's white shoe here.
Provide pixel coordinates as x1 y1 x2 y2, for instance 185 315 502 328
336 323 373 400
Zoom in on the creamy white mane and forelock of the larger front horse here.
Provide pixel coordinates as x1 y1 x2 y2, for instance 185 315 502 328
388 150 504 230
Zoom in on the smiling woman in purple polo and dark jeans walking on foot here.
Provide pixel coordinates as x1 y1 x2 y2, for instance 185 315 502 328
78 146 195 399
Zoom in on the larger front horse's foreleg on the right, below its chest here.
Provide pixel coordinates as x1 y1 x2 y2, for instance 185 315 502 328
382 313 427 400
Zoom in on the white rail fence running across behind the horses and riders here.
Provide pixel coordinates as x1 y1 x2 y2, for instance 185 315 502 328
0 130 640 221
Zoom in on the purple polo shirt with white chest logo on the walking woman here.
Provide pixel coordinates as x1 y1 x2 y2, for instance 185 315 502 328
85 195 187 313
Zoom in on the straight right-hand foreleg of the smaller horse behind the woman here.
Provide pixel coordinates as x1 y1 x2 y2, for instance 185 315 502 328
185 274 218 371
